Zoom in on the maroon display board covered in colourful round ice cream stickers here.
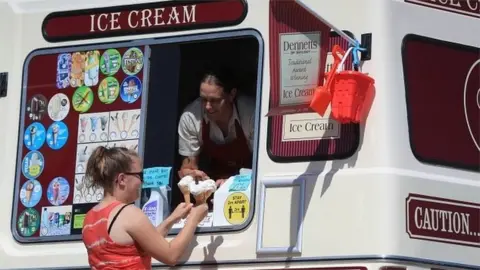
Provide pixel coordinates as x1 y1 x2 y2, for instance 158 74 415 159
12 47 145 242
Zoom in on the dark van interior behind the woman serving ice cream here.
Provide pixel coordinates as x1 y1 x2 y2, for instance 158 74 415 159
142 37 259 209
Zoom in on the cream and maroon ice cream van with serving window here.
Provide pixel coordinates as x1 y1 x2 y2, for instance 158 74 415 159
0 0 480 270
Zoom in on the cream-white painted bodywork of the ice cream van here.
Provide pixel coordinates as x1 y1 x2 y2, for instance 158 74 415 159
0 0 480 269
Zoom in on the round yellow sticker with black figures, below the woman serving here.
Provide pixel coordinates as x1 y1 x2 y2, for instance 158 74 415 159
223 192 250 225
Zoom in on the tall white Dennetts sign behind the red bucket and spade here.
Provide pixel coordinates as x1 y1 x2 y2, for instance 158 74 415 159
280 32 320 106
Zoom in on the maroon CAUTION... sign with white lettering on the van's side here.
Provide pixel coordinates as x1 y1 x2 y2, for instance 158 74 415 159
406 194 480 247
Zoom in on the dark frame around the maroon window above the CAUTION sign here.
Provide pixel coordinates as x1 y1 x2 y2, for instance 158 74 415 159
401 33 480 173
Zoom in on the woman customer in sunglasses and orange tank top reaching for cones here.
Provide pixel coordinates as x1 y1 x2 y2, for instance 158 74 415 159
82 146 208 270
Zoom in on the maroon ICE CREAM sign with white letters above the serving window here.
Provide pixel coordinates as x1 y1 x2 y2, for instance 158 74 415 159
42 0 247 42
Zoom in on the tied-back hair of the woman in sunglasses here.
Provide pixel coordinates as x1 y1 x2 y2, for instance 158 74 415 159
85 146 138 192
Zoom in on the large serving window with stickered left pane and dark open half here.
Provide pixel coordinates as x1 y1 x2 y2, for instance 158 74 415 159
11 30 263 243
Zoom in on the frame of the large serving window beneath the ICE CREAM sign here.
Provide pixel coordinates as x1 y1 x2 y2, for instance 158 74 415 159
10 28 265 244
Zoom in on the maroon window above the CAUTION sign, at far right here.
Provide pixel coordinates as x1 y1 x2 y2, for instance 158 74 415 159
402 35 480 172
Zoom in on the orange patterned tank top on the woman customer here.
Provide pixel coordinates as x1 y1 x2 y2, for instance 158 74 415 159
82 202 152 270
